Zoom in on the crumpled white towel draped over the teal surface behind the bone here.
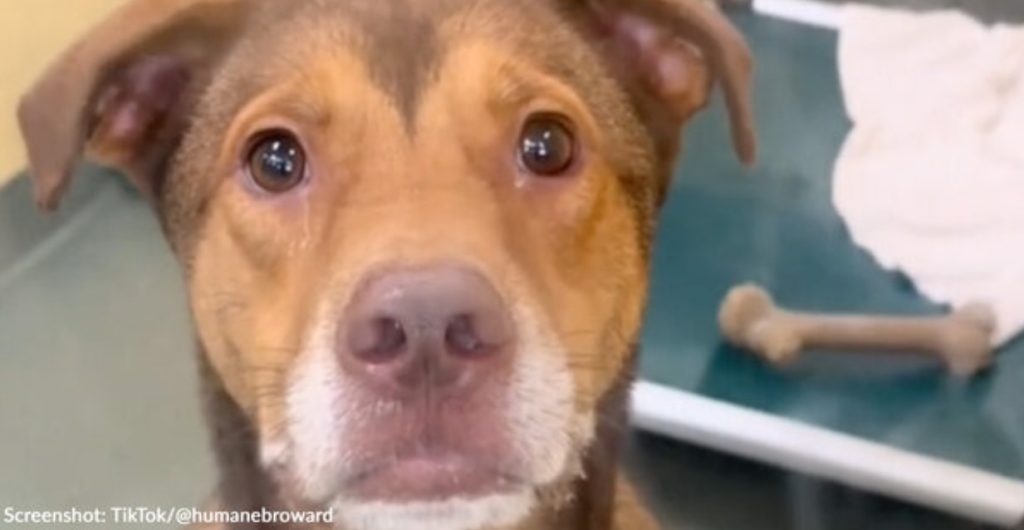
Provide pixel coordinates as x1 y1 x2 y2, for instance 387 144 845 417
833 6 1024 343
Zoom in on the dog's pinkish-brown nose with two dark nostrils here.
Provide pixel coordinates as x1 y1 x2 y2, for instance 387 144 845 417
338 267 513 390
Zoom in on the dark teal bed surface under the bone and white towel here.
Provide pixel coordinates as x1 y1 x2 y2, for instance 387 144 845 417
642 15 1024 484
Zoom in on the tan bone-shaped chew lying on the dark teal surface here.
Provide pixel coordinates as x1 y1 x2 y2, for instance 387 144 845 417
719 284 995 377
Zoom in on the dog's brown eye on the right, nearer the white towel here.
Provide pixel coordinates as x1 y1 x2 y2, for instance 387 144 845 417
519 115 575 177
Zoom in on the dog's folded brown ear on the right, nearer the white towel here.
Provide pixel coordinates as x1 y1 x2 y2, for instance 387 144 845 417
577 0 757 165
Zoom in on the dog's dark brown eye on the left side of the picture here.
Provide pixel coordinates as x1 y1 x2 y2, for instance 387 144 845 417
249 131 306 193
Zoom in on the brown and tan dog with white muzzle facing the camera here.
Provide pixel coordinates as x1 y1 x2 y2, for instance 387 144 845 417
19 0 755 530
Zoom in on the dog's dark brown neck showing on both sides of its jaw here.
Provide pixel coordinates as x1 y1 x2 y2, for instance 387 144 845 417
199 348 632 530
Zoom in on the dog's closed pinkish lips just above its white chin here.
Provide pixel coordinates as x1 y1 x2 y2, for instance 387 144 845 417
342 452 526 501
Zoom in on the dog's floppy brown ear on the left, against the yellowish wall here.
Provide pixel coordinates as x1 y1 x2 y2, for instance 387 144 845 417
17 0 247 210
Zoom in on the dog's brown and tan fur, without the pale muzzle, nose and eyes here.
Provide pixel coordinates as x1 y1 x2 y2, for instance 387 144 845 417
19 0 754 530
